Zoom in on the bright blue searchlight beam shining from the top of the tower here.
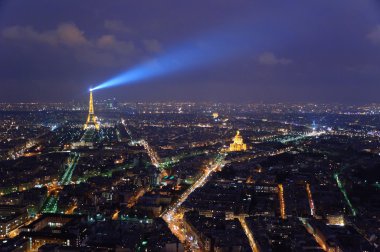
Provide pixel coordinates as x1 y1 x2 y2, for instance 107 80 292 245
91 21 280 90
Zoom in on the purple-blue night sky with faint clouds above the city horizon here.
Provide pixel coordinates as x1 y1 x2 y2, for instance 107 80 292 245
0 0 380 103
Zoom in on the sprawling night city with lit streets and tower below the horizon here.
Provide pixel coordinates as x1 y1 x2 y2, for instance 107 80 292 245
0 96 380 251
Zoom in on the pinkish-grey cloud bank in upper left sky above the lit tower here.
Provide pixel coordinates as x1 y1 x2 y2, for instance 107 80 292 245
2 23 142 67
